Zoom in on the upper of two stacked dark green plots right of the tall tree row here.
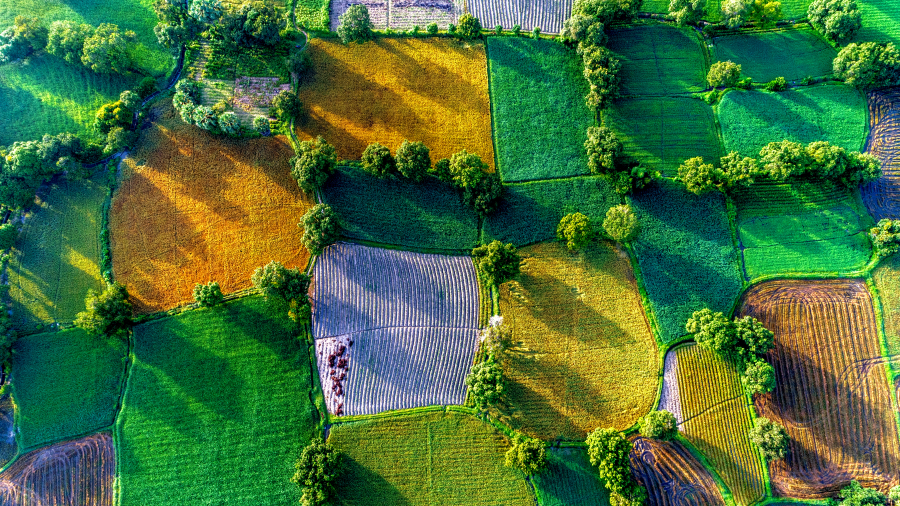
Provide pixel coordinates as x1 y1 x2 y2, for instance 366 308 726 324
607 24 708 96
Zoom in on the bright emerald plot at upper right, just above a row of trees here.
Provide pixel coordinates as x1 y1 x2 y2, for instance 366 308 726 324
719 85 869 157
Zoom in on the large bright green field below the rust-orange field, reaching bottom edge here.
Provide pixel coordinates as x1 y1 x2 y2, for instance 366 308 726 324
116 297 317 506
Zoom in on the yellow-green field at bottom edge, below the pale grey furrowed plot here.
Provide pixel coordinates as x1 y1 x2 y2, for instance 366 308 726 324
328 411 534 506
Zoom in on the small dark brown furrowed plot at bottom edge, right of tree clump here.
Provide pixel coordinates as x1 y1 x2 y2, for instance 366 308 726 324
631 436 725 506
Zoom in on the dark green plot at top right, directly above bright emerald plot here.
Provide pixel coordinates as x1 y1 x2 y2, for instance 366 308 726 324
713 27 837 83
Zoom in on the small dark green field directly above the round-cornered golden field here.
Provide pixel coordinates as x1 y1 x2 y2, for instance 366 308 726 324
484 176 621 245
